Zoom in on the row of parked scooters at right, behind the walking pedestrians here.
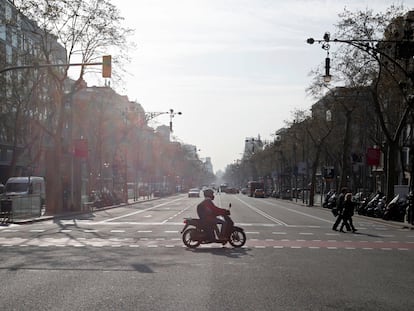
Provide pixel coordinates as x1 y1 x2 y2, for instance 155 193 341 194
323 191 414 224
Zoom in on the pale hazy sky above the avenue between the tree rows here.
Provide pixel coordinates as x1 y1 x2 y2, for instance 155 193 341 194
100 0 414 171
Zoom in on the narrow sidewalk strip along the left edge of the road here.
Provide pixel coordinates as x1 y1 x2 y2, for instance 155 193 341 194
6 197 159 225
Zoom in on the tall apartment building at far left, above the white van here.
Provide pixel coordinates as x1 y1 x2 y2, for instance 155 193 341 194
0 0 66 182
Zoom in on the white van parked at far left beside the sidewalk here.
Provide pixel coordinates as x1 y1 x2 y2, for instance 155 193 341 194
4 176 46 205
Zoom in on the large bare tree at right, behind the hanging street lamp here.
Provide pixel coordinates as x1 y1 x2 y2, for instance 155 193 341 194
311 6 412 198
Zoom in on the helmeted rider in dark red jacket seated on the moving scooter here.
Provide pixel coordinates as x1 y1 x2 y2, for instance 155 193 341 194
197 189 232 241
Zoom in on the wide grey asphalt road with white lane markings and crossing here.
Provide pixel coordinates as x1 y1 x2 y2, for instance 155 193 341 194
0 194 414 311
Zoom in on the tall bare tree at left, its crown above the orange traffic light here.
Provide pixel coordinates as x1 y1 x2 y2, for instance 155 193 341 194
15 0 131 213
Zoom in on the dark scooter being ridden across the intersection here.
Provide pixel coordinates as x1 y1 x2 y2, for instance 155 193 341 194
181 205 246 248
